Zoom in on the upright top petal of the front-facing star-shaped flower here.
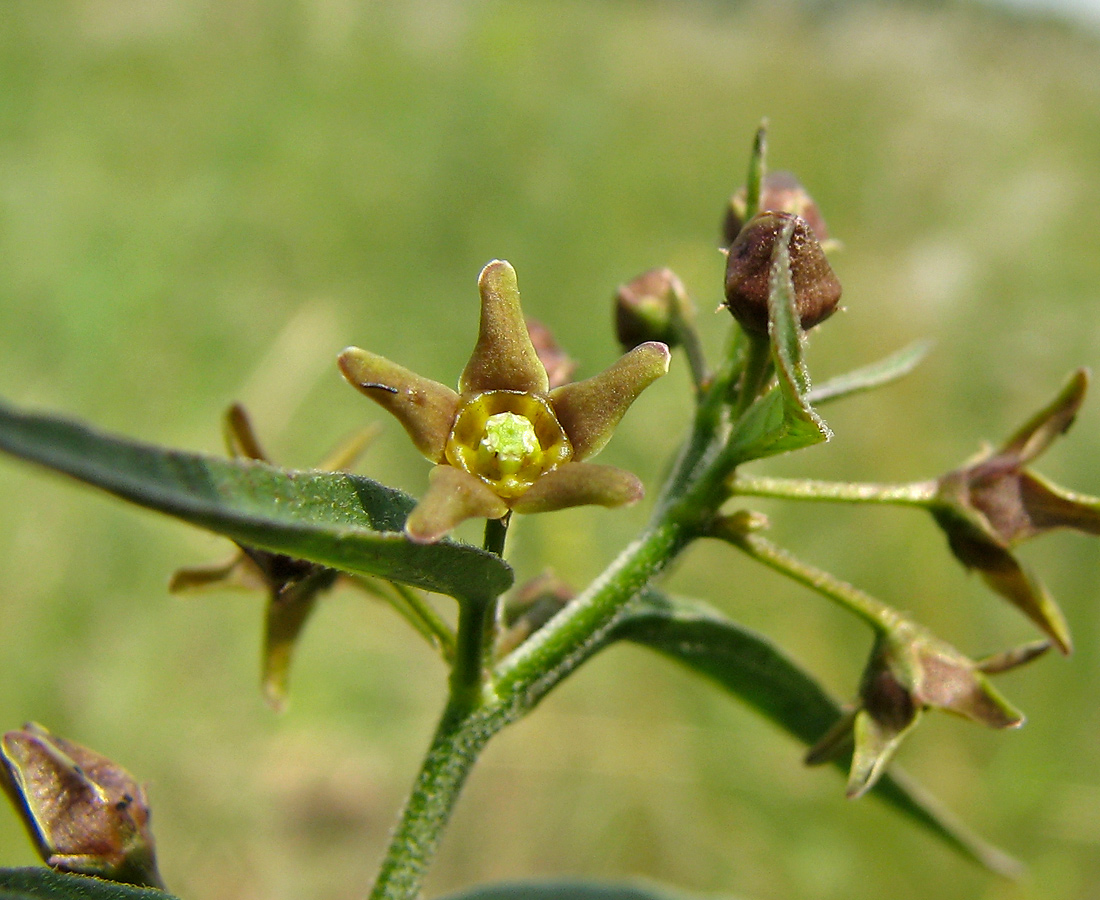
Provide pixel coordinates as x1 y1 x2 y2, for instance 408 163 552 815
459 260 550 394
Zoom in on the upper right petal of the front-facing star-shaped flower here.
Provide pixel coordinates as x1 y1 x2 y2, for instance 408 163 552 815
550 341 669 461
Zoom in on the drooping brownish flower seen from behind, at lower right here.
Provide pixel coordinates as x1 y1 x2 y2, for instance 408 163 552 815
806 621 1051 798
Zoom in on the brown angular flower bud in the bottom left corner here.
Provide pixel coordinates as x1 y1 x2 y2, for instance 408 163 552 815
0 723 163 888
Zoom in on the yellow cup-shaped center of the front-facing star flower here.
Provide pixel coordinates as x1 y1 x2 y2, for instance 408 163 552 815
444 391 573 500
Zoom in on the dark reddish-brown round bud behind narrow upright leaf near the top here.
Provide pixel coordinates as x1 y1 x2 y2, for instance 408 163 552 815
725 212 840 334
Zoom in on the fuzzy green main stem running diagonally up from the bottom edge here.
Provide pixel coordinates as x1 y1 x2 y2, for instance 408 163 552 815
371 332 740 900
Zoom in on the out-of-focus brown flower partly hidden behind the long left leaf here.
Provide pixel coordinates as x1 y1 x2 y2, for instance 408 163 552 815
168 404 373 710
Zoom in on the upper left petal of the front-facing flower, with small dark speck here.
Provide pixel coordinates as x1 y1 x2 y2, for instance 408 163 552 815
339 347 459 462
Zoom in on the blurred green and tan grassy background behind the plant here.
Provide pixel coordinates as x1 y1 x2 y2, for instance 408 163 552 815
0 0 1100 900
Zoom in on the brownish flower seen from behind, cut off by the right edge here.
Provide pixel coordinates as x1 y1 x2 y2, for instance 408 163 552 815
932 369 1100 654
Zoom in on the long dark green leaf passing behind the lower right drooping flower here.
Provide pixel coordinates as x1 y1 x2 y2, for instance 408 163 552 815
608 589 1020 875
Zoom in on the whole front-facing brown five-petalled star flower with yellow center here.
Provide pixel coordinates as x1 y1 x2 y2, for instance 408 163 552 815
339 260 669 542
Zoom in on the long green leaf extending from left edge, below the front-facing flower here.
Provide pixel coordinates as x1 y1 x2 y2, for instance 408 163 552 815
0 396 513 599
